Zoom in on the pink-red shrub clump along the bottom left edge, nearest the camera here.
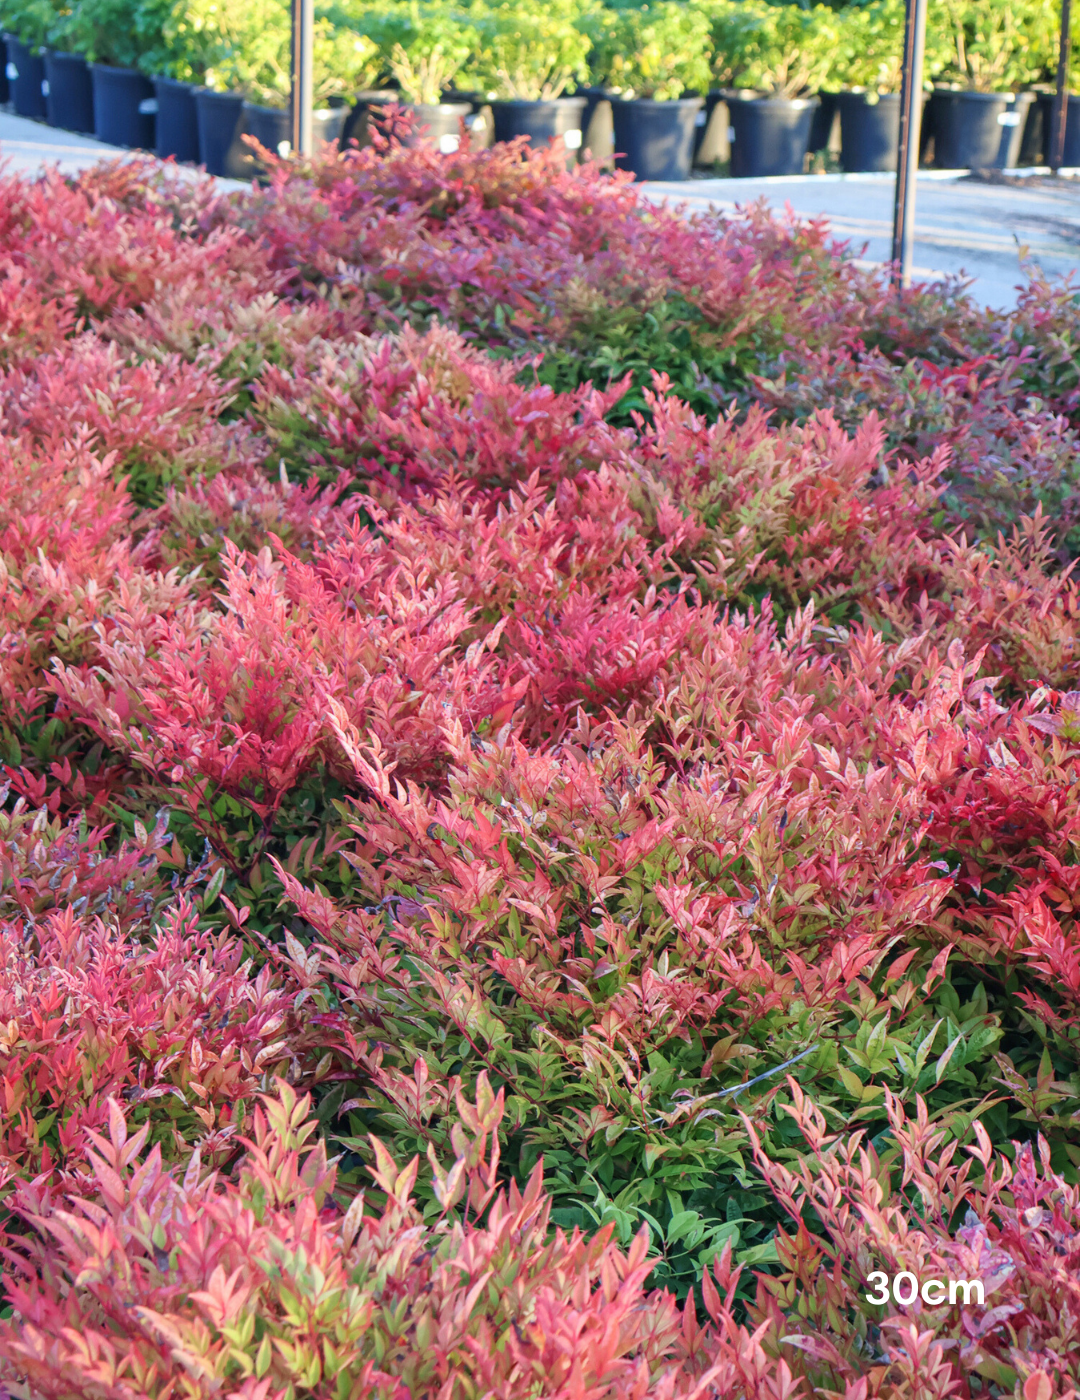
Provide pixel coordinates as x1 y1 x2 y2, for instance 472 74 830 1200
0 1079 734 1400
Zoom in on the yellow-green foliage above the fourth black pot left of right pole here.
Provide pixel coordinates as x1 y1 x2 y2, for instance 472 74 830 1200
465 0 590 102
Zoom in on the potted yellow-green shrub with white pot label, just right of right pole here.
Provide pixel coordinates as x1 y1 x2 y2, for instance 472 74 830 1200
927 0 1041 169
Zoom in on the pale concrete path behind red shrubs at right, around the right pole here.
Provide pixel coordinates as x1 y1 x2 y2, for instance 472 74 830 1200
642 171 1080 308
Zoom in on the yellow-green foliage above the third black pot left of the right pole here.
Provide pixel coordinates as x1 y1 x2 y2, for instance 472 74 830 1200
593 0 712 102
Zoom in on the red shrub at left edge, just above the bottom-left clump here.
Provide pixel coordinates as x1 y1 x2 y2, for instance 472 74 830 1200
0 879 298 1190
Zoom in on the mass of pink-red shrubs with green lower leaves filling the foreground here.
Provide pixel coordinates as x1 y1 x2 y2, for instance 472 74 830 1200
0 120 1080 1400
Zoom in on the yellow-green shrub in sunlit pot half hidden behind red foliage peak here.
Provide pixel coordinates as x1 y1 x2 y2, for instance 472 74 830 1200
354 0 479 153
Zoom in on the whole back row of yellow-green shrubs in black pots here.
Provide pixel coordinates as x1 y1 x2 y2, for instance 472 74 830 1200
0 0 1080 179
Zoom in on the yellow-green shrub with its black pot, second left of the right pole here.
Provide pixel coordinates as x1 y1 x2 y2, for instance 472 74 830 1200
714 0 840 176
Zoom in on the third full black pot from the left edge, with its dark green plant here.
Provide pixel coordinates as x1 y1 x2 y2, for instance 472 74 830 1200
52 0 155 150
